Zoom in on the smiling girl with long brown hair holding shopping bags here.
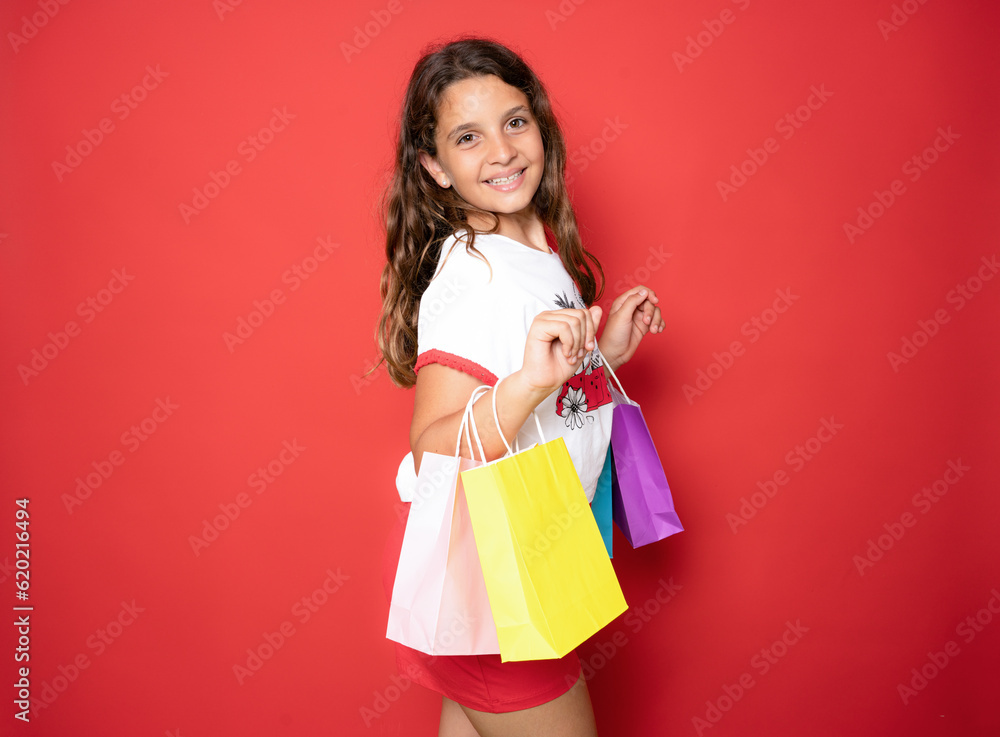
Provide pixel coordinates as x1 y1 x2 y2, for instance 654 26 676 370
377 38 664 737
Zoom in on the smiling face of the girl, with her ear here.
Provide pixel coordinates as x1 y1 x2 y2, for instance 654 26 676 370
420 75 545 228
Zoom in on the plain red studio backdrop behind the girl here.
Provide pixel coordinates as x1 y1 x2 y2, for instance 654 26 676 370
0 0 1000 737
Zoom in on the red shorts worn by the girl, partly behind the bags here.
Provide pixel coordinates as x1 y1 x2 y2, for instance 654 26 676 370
382 504 580 713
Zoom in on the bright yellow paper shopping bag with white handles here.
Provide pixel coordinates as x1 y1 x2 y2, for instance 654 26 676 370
460 374 627 662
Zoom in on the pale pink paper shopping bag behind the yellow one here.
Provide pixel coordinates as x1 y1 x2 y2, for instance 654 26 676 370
386 386 500 655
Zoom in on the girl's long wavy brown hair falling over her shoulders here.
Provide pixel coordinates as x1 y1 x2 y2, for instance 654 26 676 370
372 37 604 388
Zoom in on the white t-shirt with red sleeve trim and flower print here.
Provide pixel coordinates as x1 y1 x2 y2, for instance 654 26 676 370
396 233 613 502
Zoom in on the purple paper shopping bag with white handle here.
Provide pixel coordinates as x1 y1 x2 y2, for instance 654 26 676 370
605 364 684 548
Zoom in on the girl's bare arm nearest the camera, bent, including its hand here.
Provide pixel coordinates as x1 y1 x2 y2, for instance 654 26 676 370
410 306 601 473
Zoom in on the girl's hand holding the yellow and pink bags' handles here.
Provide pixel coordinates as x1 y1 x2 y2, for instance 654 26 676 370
521 305 602 398
